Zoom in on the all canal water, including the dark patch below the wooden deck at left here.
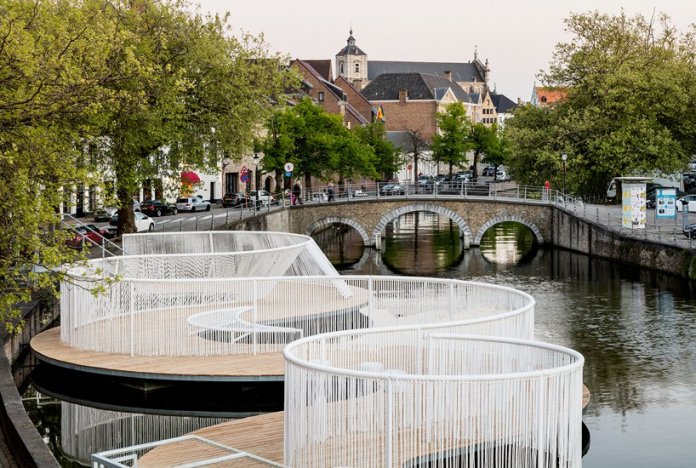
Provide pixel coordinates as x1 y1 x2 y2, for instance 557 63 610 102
19 213 696 468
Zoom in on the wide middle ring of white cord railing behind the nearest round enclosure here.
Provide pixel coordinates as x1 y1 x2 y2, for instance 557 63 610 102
61 276 535 356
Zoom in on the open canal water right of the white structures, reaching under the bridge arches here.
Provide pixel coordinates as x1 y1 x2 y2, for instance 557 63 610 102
316 213 696 468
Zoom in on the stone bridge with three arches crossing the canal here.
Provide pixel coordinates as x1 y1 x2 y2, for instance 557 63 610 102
288 198 553 248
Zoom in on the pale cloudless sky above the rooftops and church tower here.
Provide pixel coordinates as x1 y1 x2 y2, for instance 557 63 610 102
192 0 696 101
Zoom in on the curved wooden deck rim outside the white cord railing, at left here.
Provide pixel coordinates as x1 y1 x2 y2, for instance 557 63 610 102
31 327 285 382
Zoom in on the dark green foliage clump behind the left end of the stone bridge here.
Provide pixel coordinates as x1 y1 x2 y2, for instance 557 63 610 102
261 98 376 188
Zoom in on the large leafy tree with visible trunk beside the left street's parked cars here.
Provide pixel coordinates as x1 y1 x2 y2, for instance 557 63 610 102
96 0 283 234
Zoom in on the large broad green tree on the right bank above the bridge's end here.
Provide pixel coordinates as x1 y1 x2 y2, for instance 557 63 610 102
509 12 696 195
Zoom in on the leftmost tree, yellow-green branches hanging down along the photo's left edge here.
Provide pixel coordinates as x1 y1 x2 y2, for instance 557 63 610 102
0 0 119 329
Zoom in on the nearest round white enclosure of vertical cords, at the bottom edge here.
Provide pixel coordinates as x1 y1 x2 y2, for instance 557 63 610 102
284 327 583 468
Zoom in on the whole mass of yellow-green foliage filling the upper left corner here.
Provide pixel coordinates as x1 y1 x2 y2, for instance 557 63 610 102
0 0 286 327
